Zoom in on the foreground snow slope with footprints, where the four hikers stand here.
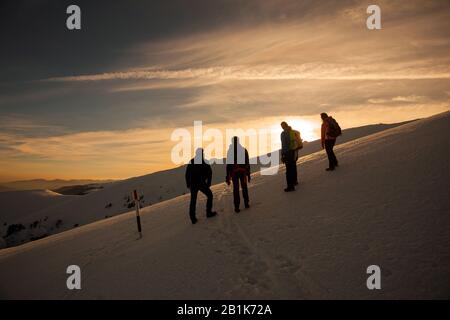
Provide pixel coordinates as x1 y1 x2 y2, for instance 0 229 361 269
0 112 450 299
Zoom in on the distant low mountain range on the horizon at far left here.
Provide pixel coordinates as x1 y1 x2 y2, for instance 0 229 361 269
0 179 114 192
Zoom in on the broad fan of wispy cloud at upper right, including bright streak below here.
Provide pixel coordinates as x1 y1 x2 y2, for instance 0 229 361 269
44 1 450 86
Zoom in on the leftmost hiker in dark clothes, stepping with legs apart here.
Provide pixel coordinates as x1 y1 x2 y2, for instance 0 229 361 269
186 148 217 224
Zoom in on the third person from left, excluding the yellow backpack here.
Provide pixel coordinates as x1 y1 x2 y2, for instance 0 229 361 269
281 121 298 192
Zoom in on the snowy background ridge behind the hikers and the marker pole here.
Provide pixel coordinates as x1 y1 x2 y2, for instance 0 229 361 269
0 120 412 246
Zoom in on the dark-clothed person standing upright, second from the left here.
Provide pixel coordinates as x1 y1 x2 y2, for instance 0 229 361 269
226 137 251 213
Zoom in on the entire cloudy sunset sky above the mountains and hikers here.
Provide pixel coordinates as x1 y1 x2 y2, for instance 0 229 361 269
0 0 450 181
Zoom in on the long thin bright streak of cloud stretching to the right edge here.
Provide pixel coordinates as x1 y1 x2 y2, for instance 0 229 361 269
46 63 450 84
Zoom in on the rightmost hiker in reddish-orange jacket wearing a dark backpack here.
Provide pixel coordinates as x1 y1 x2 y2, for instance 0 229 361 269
320 113 342 171
